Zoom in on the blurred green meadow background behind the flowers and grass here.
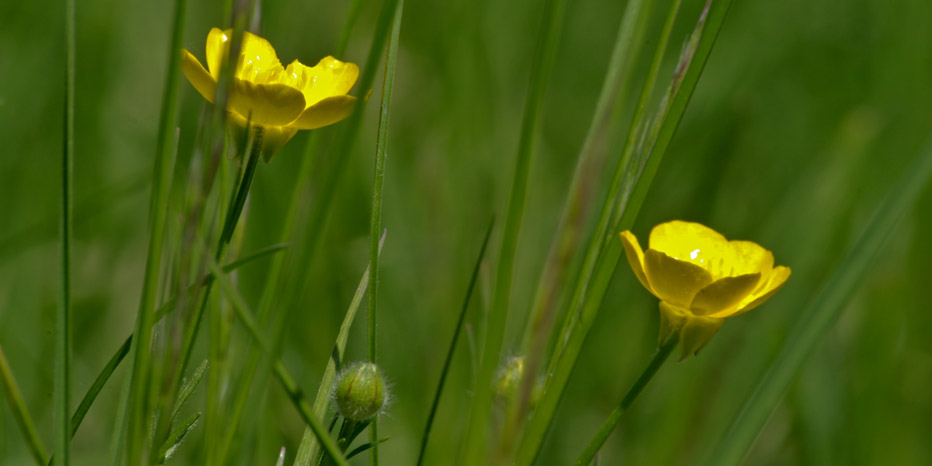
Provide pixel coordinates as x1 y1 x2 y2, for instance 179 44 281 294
0 0 932 465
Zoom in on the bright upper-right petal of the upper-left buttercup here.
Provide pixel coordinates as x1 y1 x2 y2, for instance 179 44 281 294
284 56 359 106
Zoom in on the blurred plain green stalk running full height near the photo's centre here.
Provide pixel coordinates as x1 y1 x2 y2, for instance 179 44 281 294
464 0 566 465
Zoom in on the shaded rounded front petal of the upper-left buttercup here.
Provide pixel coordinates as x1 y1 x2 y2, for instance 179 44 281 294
227 79 304 126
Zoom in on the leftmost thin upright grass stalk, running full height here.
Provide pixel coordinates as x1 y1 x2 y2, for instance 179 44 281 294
53 0 76 466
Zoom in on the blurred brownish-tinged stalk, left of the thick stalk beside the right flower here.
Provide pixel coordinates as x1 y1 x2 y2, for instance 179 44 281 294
502 0 654 451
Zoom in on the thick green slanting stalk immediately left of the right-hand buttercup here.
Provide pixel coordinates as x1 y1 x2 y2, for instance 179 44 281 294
516 0 731 466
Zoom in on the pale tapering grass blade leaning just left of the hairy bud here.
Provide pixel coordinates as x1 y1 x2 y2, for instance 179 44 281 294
294 233 385 466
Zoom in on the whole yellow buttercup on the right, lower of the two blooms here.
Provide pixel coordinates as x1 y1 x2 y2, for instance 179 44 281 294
621 220 790 360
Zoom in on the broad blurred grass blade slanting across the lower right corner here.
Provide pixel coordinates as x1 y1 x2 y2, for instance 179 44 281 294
705 133 932 465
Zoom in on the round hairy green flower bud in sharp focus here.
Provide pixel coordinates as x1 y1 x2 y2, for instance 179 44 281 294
335 362 386 421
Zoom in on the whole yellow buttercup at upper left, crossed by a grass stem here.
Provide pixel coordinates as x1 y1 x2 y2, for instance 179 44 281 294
181 28 359 161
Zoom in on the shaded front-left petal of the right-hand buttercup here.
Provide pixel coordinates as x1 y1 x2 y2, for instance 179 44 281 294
644 249 712 309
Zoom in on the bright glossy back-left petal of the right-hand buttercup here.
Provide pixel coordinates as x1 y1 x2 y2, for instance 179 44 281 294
648 220 731 278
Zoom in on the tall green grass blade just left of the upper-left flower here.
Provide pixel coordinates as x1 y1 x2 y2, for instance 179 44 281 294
123 0 187 464
